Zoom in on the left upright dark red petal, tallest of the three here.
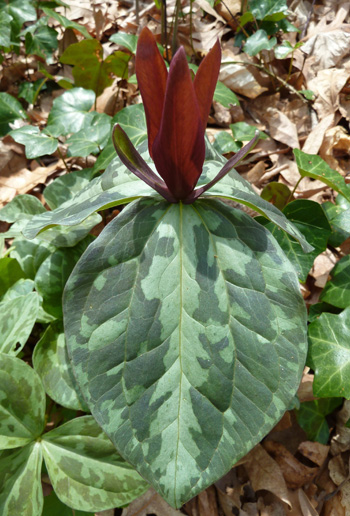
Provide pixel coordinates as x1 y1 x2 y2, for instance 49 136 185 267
135 27 168 157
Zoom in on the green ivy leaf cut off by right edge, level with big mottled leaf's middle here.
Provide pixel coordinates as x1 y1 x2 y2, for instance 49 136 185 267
320 255 350 308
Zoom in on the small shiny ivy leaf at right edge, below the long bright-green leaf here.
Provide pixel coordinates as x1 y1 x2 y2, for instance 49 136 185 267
322 195 350 247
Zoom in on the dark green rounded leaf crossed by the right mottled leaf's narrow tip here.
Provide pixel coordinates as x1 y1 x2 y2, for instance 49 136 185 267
259 199 331 282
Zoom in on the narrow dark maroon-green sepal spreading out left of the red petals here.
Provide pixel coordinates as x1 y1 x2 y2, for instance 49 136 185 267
112 124 176 202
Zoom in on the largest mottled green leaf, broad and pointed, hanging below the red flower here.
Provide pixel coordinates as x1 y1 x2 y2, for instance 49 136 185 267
64 199 306 507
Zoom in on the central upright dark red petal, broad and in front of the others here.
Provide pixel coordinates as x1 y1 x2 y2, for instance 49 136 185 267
153 48 205 200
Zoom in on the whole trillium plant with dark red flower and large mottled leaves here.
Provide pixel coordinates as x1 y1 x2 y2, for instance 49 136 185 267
62 29 312 507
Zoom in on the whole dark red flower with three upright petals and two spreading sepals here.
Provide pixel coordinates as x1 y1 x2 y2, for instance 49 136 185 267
113 28 258 203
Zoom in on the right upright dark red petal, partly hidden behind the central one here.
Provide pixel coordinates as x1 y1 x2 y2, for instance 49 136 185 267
193 40 221 127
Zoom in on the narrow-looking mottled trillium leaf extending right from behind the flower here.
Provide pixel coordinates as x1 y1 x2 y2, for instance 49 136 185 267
198 161 313 252
